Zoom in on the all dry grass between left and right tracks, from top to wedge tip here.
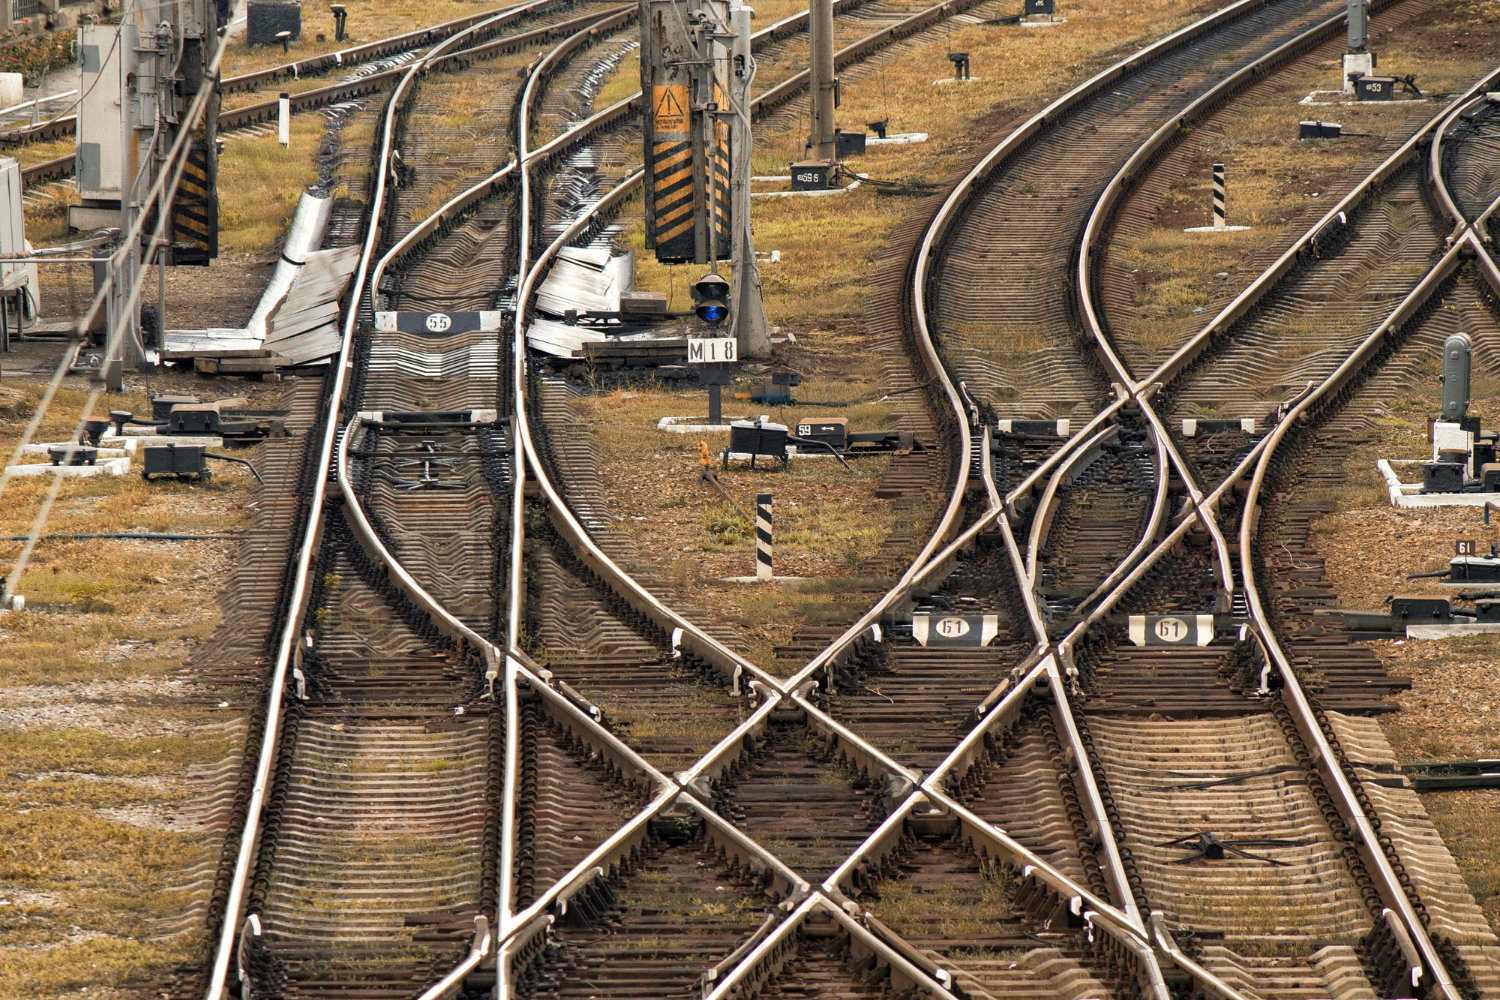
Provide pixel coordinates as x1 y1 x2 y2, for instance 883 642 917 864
573 0 1218 666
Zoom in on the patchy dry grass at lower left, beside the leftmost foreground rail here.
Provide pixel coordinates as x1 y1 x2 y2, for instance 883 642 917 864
0 384 261 997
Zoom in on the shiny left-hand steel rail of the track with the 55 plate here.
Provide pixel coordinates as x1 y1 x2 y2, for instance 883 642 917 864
196 5 612 1000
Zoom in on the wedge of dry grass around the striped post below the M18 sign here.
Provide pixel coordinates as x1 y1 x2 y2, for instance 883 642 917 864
578 359 936 664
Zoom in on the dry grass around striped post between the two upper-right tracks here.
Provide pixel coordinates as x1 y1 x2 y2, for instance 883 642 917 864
1110 3 1500 369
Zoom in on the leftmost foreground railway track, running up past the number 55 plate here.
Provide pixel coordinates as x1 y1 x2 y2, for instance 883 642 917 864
195 4 651 996
